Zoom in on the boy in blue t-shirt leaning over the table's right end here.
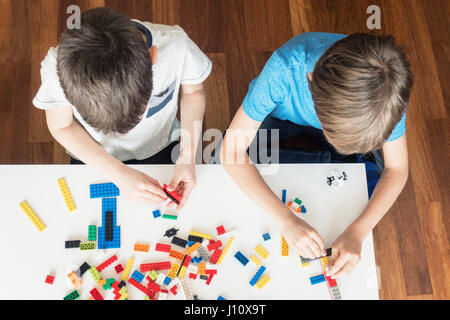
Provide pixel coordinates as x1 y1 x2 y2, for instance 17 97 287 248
220 33 412 278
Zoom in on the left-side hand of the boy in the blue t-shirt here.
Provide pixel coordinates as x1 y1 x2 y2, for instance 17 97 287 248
281 213 326 259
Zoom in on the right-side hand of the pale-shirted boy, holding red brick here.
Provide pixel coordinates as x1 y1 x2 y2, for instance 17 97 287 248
168 161 196 210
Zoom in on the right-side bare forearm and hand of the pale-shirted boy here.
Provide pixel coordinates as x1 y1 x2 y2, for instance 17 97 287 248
169 83 206 210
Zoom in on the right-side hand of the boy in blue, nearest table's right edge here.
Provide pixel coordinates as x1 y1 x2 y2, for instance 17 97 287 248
327 230 363 279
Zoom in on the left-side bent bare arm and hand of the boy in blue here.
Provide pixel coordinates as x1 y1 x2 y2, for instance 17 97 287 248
220 106 326 258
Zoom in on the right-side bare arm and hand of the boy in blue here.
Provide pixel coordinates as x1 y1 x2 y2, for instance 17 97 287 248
327 135 408 278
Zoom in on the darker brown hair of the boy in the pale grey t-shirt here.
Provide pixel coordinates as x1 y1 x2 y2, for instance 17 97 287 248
57 8 153 134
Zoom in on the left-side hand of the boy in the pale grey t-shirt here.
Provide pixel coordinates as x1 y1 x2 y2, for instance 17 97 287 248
114 166 167 204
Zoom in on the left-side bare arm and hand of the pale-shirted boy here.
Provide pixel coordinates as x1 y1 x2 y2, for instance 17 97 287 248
45 106 167 203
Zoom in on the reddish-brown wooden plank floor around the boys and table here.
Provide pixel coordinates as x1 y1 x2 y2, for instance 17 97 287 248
0 0 450 299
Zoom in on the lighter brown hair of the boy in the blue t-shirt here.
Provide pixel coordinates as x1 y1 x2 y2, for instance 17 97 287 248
310 34 413 154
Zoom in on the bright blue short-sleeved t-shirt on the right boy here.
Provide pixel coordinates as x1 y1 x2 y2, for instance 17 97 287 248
242 32 406 141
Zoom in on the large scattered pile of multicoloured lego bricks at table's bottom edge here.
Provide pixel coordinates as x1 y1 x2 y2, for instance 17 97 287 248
54 222 239 300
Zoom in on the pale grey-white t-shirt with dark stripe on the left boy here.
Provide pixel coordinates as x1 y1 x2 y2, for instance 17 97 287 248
33 20 212 161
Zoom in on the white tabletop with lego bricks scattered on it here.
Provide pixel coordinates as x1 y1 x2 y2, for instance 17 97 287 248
0 164 378 299
